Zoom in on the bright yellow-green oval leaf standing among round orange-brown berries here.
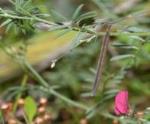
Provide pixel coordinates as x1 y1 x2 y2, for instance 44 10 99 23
24 96 37 122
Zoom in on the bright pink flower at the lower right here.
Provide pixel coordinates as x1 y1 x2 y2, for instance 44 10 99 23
114 91 129 116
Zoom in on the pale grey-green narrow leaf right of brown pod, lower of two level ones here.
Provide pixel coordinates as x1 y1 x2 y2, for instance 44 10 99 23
110 54 135 61
